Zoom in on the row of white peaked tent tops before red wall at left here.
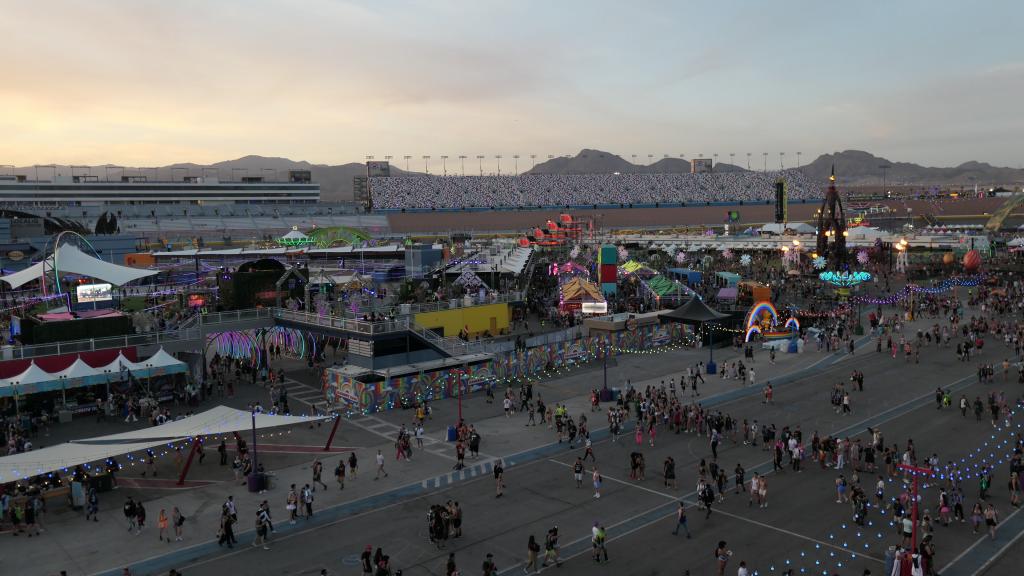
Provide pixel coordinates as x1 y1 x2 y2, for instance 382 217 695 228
0 348 188 398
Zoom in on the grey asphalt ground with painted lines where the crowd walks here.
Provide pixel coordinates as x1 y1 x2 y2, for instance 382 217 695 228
8 297 1024 576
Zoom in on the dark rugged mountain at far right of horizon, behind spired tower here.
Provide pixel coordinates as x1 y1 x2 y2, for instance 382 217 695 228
802 150 1024 186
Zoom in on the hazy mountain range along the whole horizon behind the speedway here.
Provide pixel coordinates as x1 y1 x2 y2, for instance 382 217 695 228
13 149 1024 202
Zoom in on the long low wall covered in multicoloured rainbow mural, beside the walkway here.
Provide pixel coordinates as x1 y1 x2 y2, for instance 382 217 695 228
323 324 685 415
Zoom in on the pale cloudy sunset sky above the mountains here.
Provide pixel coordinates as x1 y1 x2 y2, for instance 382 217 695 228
0 0 1024 172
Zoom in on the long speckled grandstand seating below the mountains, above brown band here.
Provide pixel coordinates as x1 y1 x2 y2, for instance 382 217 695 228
370 170 821 210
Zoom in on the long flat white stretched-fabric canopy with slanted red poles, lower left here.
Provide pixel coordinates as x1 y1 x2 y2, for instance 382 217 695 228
0 406 332 483
